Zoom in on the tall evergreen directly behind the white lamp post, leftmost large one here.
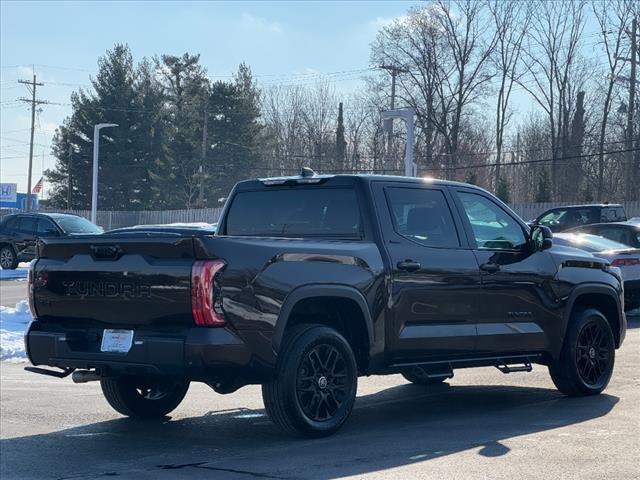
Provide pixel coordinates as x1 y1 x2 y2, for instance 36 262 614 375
46 44 159 210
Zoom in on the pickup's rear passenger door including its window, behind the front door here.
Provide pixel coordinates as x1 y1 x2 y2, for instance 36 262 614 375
374 182 481 362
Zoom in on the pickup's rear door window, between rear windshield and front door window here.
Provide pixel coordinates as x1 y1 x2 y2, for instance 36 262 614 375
386 187 460 248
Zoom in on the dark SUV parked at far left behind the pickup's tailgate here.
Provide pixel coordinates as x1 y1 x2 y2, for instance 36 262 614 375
0 213 102 269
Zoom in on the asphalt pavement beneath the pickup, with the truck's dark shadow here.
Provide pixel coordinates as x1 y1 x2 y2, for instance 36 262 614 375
0 280 640 480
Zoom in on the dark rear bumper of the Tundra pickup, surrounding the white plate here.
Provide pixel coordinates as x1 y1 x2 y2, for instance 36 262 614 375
25 321 253 382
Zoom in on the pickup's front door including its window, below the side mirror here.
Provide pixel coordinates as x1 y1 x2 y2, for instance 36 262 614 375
452 188 559 354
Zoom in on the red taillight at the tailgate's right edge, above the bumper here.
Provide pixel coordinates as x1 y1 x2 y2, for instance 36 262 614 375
191 260 225 327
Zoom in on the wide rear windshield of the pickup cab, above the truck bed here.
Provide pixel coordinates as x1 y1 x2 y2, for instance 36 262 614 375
226 188 362 238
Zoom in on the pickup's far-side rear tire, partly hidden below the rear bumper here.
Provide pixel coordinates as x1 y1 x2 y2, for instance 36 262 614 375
100 376 189 418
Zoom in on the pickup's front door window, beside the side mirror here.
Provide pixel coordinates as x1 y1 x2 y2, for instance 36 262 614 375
458 192 527 250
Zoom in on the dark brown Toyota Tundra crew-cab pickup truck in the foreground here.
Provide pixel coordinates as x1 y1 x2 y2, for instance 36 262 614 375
26 170 626 436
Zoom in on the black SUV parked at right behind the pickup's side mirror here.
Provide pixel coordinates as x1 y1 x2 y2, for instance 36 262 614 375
531 204 627 232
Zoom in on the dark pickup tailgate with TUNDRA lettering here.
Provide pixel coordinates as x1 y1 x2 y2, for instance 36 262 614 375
33 235 199 327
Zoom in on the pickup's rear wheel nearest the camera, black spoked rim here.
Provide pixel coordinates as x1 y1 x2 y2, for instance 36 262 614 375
262 325 358 437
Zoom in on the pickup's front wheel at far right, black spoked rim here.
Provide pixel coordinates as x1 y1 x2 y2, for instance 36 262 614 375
549 308 615 397
